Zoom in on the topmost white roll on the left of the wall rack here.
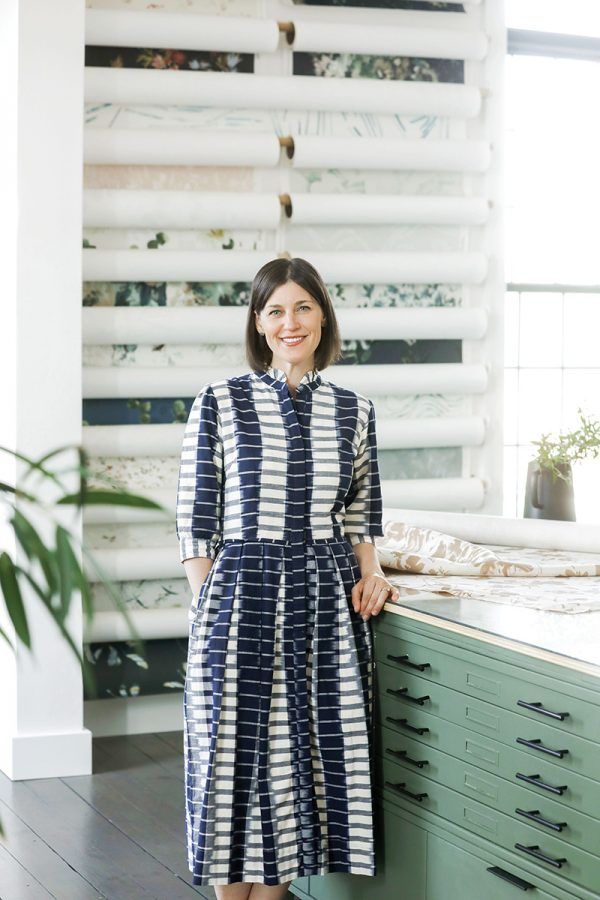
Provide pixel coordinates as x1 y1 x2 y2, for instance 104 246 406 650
85 9 279 53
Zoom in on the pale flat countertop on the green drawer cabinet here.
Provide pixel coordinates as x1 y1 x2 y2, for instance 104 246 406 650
384 580 600 678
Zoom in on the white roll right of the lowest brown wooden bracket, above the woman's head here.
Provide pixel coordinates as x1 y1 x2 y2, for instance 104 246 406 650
290 194 489 225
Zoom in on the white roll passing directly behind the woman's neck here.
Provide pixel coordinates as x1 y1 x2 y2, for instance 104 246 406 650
83 363 488 399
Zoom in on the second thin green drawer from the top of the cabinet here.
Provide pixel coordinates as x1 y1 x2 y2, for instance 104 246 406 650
376 663 600 783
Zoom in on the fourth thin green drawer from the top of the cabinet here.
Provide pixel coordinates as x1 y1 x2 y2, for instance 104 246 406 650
376 726 600 854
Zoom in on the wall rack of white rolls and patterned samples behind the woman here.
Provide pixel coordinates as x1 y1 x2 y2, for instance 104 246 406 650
78 0 503 732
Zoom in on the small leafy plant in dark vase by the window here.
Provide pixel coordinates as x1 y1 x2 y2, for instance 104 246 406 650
523 407 600 522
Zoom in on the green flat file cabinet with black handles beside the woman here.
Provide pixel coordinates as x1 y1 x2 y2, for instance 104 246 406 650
292 607 600 900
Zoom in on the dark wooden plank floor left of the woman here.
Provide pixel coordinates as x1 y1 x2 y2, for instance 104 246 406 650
0 732 292 900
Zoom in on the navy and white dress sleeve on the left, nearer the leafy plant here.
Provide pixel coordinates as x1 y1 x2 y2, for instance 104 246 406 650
175 384 224 562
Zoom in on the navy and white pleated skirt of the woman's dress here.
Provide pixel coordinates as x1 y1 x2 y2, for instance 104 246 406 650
184 539 375 885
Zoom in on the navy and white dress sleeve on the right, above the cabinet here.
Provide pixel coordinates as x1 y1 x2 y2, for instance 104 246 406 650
344 400 383 545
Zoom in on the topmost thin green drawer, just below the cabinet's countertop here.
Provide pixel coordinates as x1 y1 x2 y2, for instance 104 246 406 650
375 627 600 743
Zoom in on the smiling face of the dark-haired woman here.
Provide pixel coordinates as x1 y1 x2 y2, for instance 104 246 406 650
254 281 324 369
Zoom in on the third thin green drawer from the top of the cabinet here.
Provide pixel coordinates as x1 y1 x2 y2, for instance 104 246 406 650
375 695 600 818
